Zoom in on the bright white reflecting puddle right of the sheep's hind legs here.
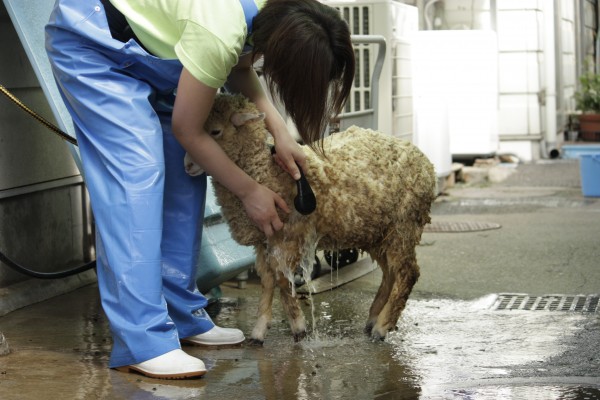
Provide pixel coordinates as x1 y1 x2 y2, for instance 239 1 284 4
388 296 600 399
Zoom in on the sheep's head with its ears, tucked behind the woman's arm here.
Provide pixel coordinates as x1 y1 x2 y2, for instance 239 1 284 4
184 94 267 176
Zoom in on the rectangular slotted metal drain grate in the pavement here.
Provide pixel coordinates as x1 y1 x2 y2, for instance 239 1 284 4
491 293 600 313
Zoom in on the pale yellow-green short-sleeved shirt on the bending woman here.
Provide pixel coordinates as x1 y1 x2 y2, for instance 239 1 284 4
110 0 266 88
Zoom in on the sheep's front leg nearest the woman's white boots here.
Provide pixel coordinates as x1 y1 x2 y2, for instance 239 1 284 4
248 248 275 346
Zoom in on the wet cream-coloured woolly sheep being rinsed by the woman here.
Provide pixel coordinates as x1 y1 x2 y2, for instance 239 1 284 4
185 94 437 345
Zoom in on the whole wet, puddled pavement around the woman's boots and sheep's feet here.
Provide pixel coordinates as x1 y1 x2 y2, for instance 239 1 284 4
0 277 600 400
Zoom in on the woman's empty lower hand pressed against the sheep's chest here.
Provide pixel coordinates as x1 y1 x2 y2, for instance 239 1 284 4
241 183 290 237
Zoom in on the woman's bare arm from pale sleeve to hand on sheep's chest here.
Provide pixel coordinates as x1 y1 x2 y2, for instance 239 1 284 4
172 68 290 236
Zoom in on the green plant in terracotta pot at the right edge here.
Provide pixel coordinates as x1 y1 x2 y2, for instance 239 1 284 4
575 72 600 142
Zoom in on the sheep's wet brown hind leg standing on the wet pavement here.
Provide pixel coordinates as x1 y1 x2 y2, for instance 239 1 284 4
371 246 419 340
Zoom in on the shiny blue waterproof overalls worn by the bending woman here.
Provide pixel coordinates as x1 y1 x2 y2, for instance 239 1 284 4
46 0 257 367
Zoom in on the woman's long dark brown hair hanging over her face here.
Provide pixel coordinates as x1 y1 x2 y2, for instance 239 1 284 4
252 0 354 152
